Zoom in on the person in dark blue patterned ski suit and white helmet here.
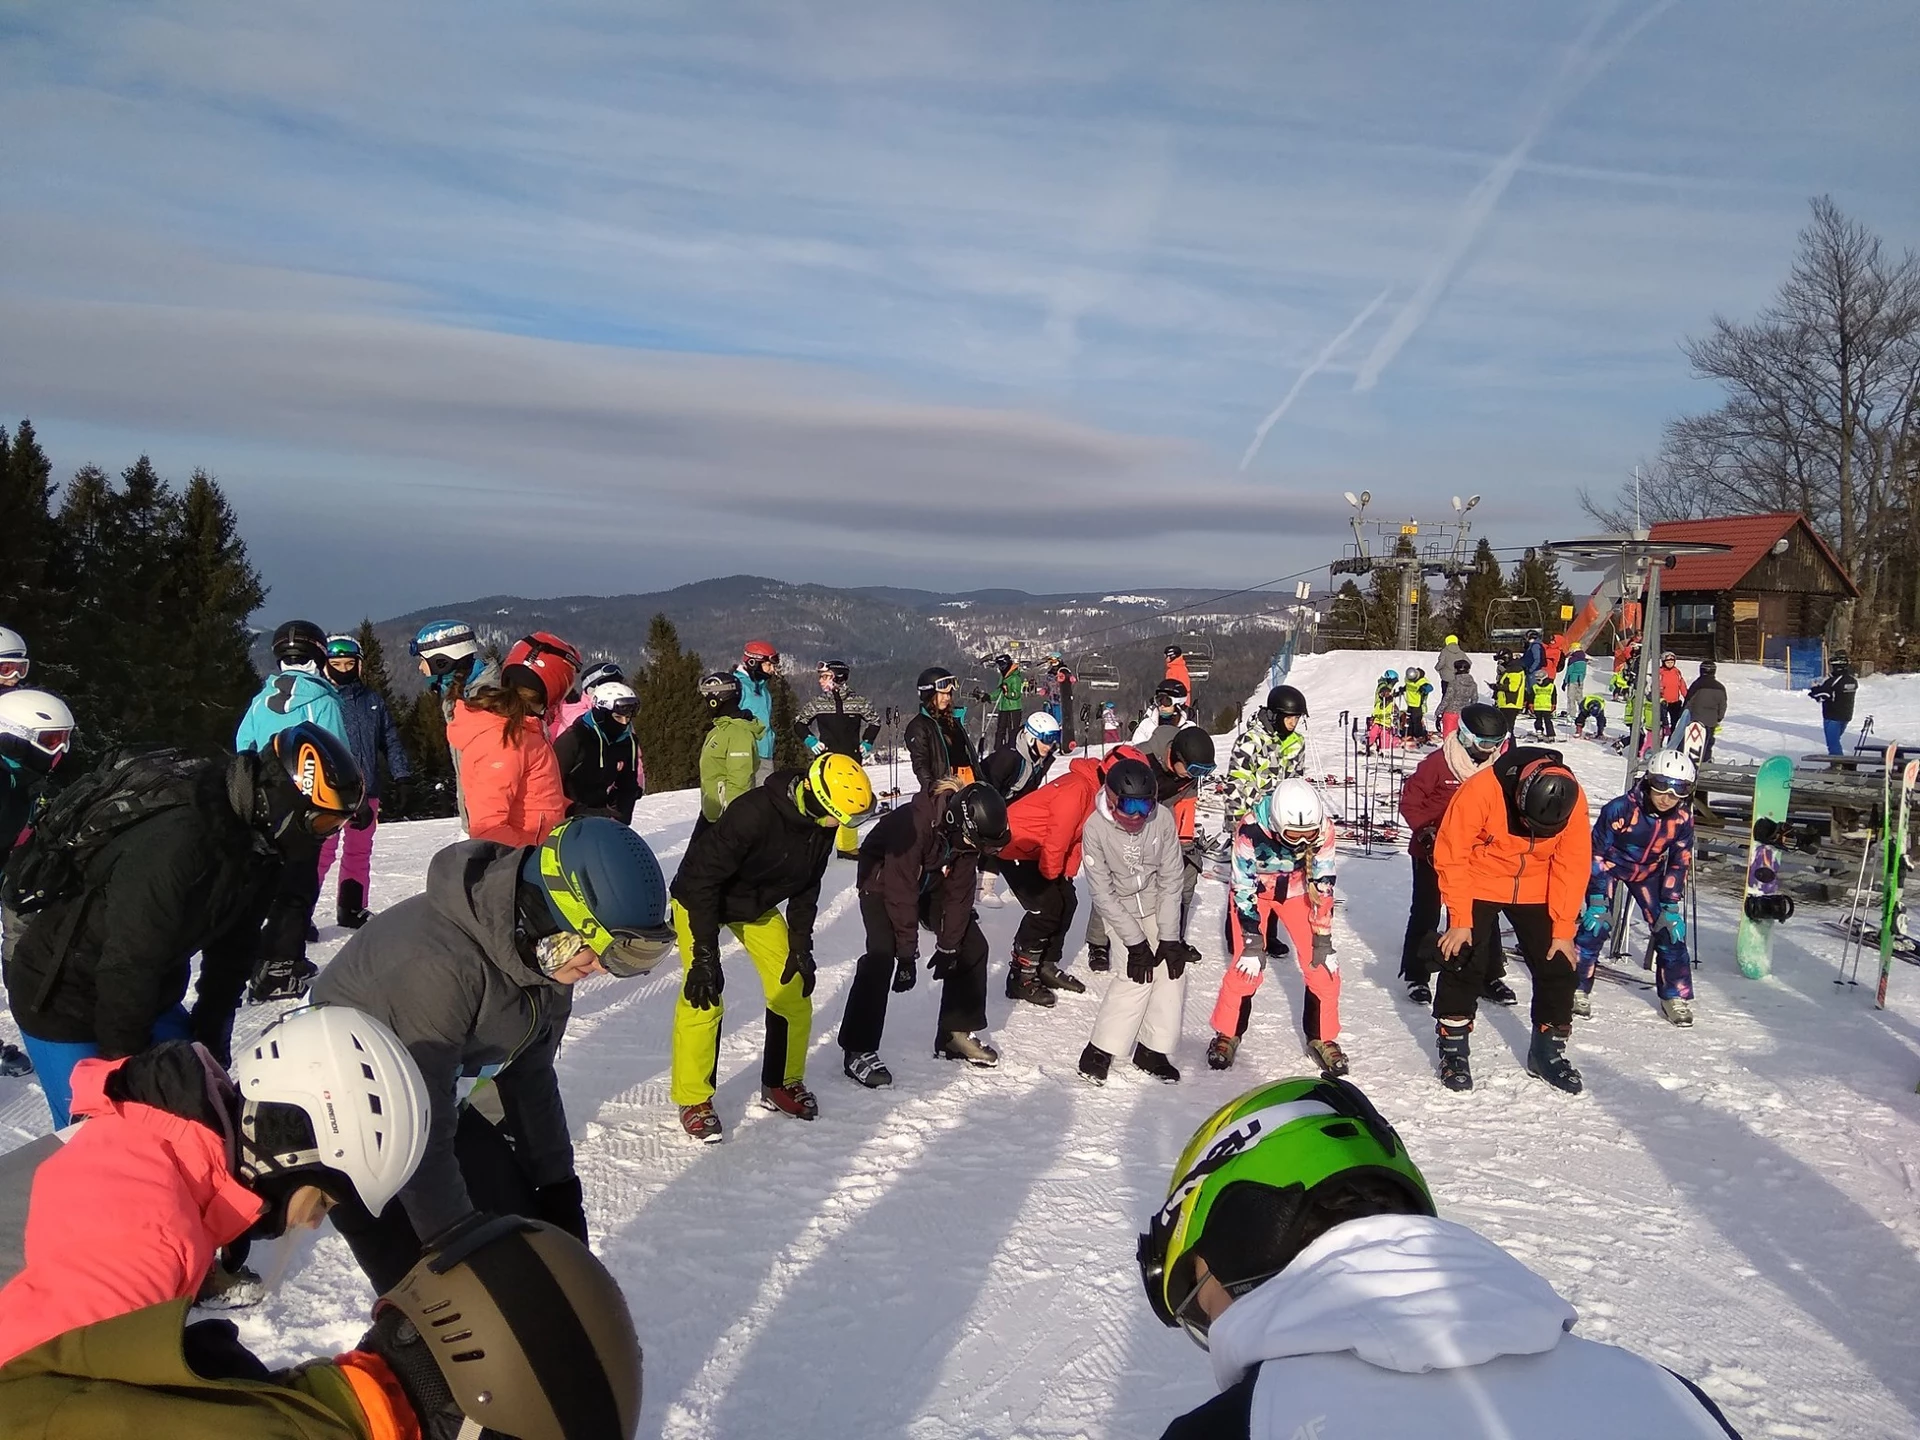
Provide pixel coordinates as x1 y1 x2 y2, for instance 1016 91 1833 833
1572 749 1693 1025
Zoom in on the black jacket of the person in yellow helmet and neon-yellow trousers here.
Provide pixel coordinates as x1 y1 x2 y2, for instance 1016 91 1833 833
668 770 835 954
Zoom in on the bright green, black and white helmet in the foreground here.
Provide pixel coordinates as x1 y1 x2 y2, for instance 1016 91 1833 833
1139 1077 1434 1344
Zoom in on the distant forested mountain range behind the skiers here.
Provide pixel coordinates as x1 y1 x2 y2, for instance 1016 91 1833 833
374 576 1288 733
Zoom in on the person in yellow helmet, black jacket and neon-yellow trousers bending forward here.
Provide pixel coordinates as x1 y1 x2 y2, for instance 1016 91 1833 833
672 755 874 1144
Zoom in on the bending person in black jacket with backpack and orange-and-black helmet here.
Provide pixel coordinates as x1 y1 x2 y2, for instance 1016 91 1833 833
4 722 363 1129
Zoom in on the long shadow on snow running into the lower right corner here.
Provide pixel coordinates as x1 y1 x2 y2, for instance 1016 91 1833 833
1592 1064 1920 1421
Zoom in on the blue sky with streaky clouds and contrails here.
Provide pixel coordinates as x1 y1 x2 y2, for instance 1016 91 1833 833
0 0 1920 622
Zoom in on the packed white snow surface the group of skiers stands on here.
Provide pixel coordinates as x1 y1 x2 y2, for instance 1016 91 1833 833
0 653 1920 1440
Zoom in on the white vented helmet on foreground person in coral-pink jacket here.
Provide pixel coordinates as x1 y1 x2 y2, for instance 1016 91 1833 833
232 1004 428 1215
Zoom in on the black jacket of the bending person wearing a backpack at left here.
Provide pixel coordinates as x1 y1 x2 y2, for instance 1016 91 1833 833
6 755 280 1066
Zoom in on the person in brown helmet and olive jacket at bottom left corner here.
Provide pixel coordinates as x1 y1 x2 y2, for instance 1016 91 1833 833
0 1215 641 1440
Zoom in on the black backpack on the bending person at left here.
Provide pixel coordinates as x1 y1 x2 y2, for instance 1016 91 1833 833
0 747 207 916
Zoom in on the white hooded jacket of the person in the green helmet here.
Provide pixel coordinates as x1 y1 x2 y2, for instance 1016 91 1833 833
1169 1215 1738 1440
